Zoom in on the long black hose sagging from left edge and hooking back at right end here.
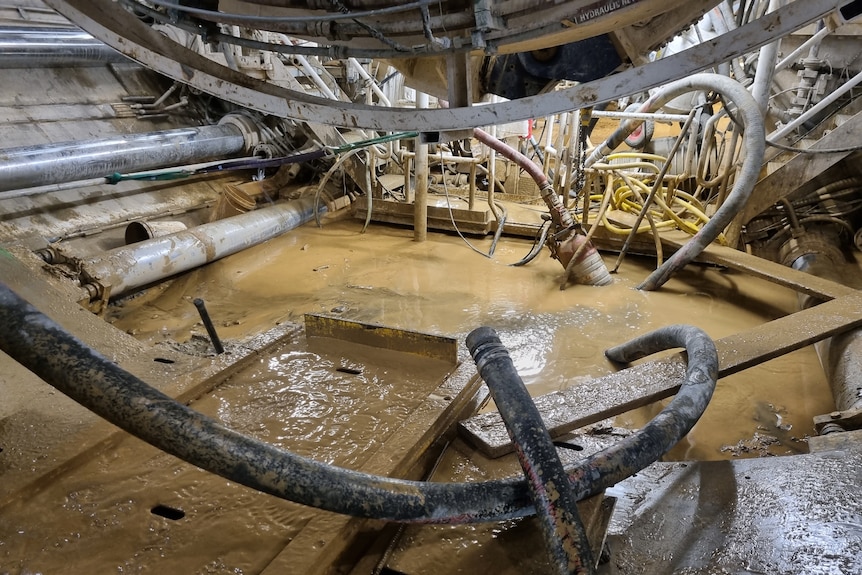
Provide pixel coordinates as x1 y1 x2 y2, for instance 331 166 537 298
0 283 718 524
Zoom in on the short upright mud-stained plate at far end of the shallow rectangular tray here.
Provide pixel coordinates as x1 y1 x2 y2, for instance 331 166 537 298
305 313 458 365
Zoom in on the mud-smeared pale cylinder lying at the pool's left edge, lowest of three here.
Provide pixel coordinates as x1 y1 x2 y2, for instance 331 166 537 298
82 198 326 297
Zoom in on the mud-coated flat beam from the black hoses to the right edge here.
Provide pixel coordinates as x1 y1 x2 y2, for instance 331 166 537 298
459 292 862 457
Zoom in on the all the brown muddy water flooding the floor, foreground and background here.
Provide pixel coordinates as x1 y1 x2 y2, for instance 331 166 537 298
0 214 832 574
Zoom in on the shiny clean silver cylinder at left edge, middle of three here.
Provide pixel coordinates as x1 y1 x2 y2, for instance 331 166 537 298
0 124 246 192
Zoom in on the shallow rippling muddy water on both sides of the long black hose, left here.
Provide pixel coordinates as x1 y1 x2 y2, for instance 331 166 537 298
0 326 451 575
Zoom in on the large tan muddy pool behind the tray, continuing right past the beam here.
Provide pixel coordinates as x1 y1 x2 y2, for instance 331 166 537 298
111 220 832 459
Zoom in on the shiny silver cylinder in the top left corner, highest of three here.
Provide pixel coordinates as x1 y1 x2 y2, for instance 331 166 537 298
0 26 130 68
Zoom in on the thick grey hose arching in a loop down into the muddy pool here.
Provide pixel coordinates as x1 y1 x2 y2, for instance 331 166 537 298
586 74 766 290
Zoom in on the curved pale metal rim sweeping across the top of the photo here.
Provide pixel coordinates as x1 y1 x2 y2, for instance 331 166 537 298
46 0 850 132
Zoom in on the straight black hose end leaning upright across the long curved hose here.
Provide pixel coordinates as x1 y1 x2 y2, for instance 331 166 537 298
467 327 595 575
